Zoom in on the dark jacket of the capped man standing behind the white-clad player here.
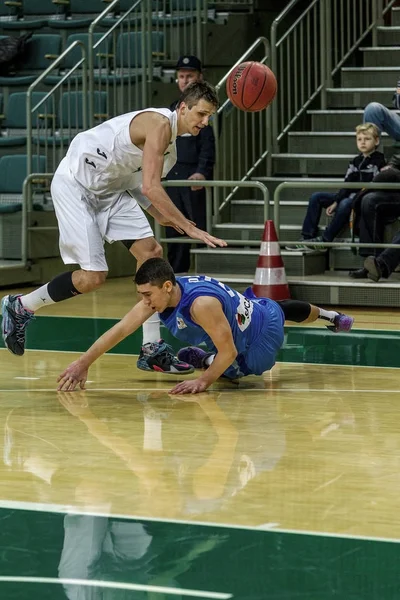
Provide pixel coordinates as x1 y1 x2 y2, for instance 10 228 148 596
170 102 215 179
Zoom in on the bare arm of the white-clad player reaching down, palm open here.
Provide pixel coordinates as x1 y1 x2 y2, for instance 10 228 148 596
141 113 227 248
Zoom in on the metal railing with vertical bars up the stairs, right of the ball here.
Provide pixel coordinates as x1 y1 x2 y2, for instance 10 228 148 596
270 0 396 152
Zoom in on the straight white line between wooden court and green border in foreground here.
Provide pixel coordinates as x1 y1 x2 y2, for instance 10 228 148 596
0 499 400 544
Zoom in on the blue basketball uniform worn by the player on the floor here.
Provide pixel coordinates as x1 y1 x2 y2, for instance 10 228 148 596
160 275 284 375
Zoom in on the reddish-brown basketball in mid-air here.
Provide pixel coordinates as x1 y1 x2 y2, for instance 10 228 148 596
226 61 277 112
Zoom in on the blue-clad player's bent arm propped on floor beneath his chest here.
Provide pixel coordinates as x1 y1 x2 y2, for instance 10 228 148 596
171 296 237 394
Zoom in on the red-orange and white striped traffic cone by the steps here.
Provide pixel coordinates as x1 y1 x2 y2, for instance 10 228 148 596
253 221 290 300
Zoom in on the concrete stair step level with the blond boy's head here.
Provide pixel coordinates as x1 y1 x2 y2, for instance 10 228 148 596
289 131 394 155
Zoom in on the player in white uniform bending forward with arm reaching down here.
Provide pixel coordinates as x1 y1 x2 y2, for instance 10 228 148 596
2 81 226 373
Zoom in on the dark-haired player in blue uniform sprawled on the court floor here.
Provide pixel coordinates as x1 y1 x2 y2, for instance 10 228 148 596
58 258 354 394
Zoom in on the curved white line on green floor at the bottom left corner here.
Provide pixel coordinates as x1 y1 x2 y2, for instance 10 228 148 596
0 575 232 600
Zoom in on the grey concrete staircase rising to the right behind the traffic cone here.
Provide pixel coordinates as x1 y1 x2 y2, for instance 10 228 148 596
192 1 400 306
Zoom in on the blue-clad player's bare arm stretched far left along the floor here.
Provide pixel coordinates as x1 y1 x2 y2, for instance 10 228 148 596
57 302 154 392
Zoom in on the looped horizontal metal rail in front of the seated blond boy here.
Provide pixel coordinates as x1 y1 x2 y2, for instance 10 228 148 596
274 179 400 248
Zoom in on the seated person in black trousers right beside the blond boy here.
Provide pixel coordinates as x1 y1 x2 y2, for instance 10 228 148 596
349 154 400 279
